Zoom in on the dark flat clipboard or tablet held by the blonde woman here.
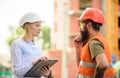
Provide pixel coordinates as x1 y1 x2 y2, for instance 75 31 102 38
24 60 58 77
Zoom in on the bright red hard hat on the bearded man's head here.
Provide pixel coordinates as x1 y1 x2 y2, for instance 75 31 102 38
78 8 104 24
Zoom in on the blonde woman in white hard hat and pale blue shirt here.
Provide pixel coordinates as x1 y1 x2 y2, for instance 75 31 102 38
11 13 51 78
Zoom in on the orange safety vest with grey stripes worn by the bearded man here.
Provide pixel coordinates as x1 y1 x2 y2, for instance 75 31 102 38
77 34 115 78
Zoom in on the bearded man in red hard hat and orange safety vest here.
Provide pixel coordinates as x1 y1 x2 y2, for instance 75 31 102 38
74 8 114 78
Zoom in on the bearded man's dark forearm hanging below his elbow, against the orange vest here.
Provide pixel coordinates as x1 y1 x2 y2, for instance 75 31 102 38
93 67 107 78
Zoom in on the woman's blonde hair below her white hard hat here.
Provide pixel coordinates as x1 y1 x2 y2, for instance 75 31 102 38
23 23 32 41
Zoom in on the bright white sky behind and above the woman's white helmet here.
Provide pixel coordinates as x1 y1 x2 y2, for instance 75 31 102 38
0 0 53 54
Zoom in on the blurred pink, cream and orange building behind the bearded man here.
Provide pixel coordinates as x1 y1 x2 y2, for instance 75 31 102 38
50 0 120 78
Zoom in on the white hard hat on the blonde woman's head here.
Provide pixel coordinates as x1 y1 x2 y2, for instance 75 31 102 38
19 13 42 27
